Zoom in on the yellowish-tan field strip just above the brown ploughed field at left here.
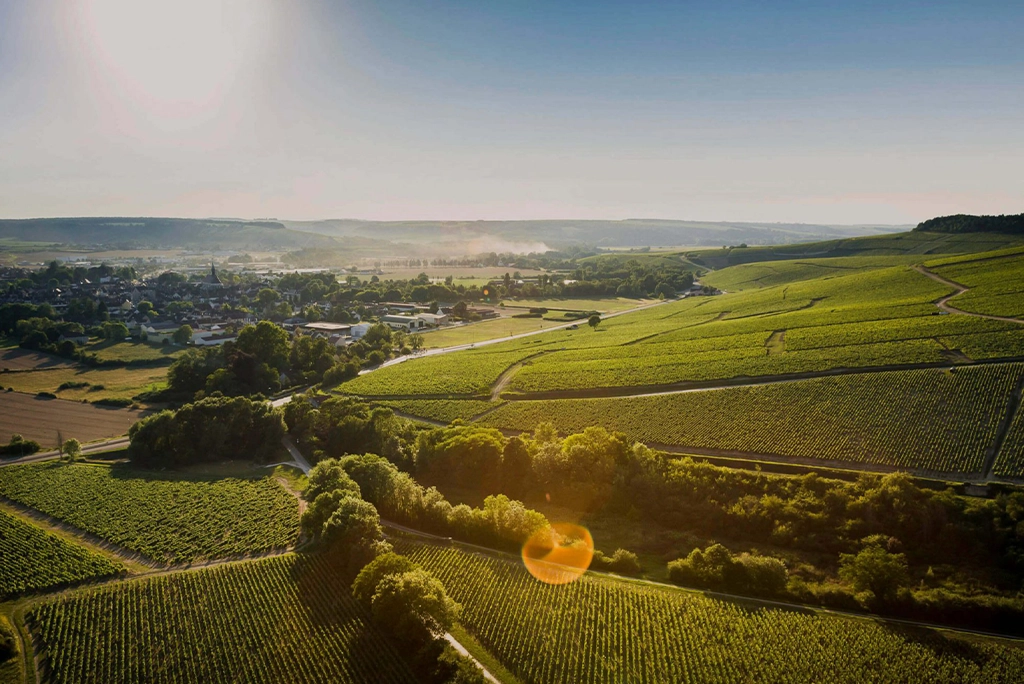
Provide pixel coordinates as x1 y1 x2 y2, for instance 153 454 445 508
0 366 167 401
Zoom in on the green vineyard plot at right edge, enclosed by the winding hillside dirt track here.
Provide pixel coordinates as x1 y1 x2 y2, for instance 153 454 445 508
932 253 1024 317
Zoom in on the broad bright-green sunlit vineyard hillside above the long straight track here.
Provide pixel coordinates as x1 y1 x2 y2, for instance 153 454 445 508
342 256 1024 401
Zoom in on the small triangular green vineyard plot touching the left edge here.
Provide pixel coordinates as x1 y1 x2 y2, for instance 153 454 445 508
0 511 125 601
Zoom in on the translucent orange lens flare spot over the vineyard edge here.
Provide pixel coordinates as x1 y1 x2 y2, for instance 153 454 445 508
522 522 594 585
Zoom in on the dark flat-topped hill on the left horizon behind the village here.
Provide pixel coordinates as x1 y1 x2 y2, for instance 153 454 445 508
0 217 339 250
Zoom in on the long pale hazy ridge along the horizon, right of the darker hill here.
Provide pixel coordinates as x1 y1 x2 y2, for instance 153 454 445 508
283 218 910 253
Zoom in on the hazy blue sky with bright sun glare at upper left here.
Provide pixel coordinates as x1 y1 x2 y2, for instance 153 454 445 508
0 0 1024 224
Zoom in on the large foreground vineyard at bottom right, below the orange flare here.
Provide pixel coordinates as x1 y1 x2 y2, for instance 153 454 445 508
398 542 1024 684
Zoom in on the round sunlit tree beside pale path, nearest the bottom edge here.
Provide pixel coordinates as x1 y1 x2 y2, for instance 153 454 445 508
371 568 462 643
